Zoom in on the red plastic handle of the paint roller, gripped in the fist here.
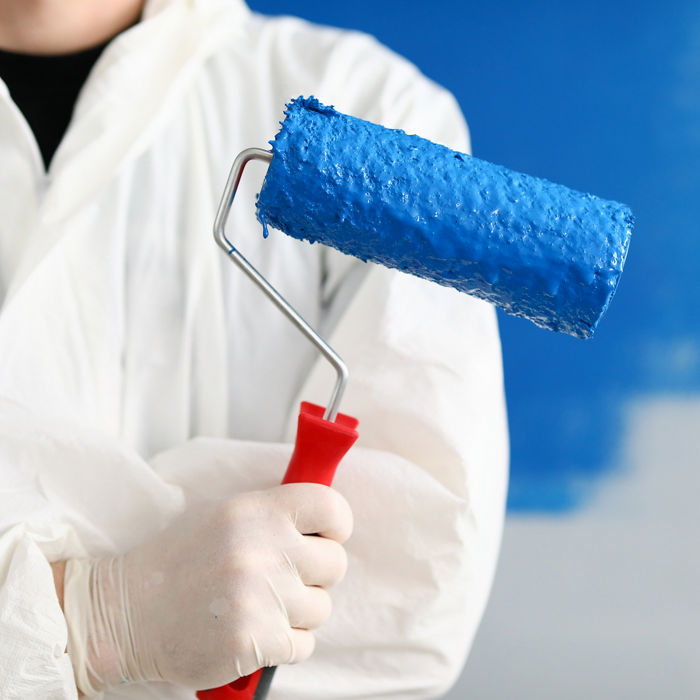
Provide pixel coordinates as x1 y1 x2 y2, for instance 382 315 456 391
197 401 358 700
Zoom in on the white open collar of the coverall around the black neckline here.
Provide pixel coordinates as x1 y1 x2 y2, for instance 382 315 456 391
0 0 250 303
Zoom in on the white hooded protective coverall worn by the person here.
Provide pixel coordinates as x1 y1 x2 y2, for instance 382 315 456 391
0 0 508 700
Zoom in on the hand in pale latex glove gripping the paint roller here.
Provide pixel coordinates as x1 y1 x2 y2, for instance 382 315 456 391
64 484 352 695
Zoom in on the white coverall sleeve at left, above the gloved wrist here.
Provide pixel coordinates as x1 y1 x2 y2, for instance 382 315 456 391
0 399 183 700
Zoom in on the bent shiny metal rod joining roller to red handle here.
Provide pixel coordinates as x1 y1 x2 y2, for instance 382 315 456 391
214 148 348 421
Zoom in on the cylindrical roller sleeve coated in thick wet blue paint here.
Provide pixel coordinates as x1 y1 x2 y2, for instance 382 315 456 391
257 97 633 338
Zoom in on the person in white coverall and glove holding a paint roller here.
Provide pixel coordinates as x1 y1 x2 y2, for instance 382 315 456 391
0 0 508 700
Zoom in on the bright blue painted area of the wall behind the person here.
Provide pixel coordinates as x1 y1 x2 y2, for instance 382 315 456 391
249 0 700 512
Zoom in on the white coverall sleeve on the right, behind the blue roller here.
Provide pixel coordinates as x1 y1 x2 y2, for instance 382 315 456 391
270 34 509 698
